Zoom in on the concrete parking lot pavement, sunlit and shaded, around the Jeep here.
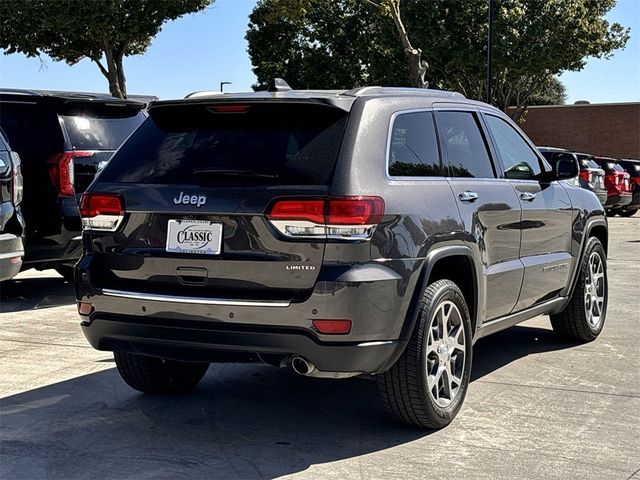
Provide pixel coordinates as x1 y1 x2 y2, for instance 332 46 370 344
0 214 640 480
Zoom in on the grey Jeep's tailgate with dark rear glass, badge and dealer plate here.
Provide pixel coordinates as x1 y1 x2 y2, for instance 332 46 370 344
91 102 347 300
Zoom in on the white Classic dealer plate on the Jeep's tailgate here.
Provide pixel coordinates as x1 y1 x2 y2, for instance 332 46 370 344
167 220 222 255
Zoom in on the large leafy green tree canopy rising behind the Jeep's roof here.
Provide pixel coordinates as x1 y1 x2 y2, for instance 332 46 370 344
247 0 629 119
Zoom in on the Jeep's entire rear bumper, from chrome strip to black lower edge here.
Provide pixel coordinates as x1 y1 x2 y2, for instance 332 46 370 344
76 257 420 373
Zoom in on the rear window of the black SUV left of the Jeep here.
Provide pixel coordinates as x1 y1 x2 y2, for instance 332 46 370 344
60 112 145 150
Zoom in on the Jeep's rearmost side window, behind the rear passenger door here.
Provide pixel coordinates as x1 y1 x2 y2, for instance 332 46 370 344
389 112 442 177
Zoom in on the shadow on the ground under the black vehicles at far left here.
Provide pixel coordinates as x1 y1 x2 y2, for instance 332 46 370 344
0 275 75 313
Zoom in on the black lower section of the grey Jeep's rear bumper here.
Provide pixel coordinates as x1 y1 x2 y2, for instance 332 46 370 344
81 314 402 373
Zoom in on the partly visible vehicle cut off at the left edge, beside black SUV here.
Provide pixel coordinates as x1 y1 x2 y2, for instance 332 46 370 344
0 129 24 282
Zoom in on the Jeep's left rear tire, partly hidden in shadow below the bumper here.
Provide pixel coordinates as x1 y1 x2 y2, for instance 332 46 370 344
113 352 209 394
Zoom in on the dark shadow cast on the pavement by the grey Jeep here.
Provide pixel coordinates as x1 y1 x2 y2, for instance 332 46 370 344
0 327 570 479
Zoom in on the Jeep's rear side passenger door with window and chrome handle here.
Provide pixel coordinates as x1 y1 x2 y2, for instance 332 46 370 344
436 109 523 320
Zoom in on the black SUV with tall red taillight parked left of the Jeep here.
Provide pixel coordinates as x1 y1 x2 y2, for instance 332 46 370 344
0 89 146 280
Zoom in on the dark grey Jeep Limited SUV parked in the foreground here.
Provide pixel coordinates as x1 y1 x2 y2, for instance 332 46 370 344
76 82 607 428
